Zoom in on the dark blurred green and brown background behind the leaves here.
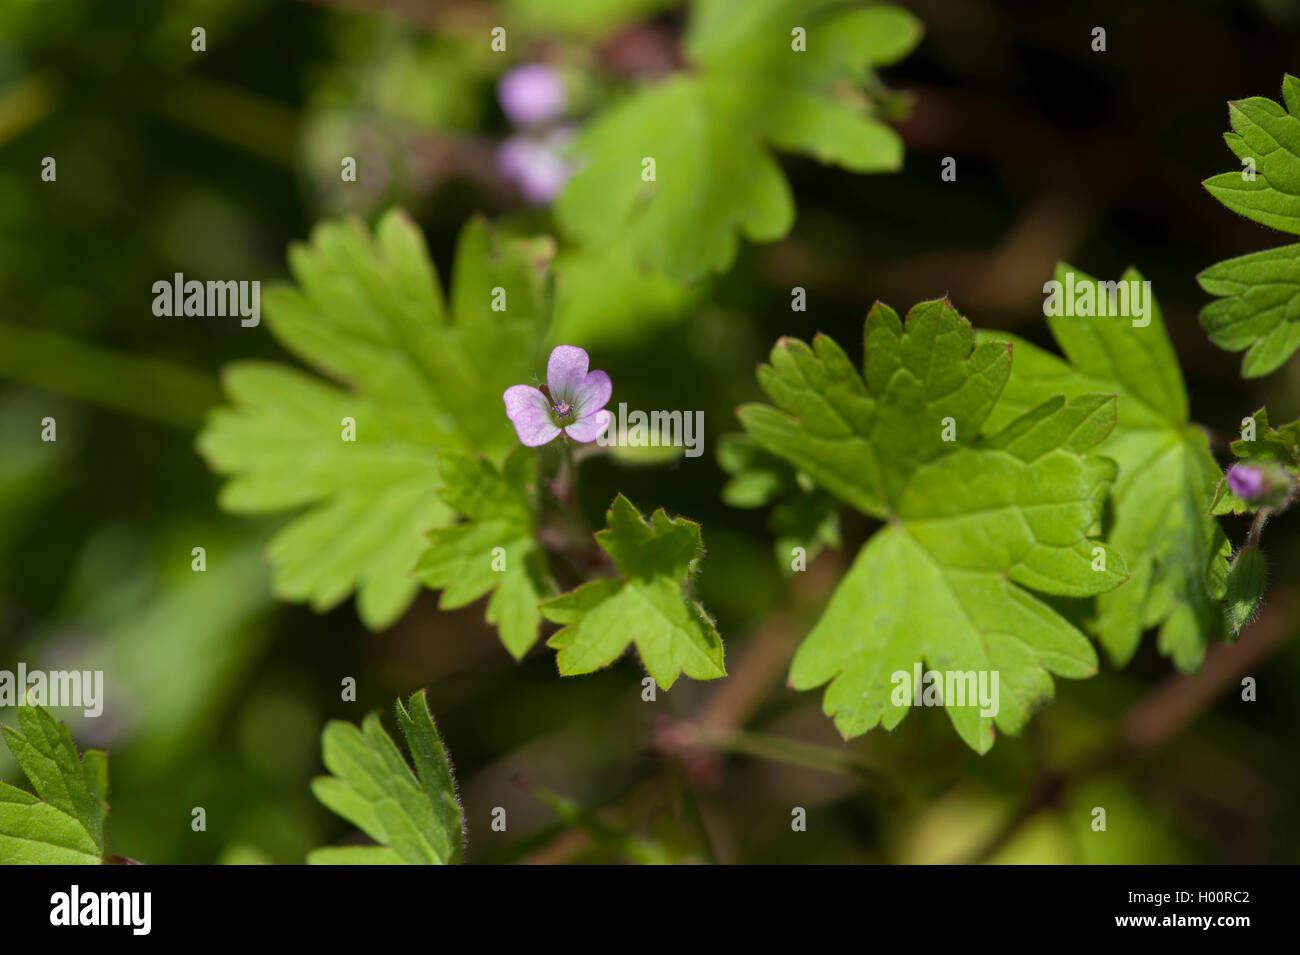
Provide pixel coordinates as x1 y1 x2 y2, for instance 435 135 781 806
0 0 1300 863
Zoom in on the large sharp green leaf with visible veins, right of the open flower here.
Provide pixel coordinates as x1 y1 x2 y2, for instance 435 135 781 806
738 300 1125 752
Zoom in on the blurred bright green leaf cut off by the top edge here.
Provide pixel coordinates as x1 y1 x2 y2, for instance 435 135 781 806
556 0 920 281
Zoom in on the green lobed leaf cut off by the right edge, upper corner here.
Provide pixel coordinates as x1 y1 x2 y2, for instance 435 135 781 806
1196 74 1300 378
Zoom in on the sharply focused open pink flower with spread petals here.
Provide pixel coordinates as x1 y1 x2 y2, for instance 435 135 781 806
502 344 614 448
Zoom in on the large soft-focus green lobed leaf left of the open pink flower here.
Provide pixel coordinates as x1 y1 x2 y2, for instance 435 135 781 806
199 212 550 629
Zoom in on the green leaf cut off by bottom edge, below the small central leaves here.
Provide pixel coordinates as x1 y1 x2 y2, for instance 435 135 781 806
307 690 465 865
